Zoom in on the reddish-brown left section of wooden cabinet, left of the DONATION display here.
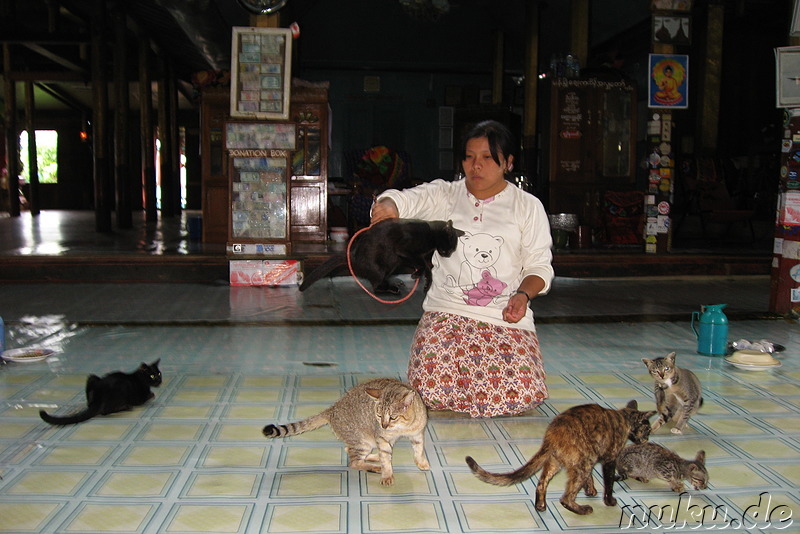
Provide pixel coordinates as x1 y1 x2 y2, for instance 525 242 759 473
200 88 230 244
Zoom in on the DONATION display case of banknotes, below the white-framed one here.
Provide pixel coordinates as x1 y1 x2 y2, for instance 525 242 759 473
225 122 297 255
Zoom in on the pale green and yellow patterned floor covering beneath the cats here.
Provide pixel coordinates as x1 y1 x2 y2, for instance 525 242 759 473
0 310 800 533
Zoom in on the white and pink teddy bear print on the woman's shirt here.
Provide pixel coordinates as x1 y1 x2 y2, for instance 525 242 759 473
447 232 508 306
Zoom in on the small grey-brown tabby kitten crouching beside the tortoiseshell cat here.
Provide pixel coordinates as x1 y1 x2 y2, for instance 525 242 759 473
617 442 708 493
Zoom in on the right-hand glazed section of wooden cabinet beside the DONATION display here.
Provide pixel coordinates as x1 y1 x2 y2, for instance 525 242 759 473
289 84 330 243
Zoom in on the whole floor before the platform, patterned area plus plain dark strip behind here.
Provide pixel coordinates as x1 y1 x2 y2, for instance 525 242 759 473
0 211 800 534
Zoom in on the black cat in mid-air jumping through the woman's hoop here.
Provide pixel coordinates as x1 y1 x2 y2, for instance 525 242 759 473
300 219 464 294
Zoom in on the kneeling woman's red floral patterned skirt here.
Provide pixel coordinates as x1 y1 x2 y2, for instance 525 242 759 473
408 312 547 417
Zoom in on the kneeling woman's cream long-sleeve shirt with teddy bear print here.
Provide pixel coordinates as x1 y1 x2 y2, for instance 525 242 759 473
378 180 554 331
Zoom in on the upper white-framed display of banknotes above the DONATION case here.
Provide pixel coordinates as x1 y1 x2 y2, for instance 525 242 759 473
230 26 292 120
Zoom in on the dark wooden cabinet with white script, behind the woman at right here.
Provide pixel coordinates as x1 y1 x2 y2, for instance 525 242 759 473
549 78 636 215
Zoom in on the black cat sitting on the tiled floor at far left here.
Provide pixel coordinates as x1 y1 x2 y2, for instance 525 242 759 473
39 359 161 425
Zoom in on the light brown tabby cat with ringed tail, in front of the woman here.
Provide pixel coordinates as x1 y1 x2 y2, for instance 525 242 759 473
263 378 430 486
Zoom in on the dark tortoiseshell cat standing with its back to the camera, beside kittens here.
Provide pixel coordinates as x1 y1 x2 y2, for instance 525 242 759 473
467 400 656 515
